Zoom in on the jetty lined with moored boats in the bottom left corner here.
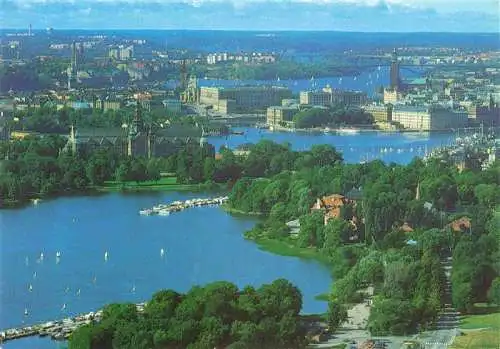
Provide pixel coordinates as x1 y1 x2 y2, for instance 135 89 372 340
0 303 146 344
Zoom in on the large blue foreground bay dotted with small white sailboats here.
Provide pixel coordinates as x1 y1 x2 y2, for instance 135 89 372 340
0 193 331 349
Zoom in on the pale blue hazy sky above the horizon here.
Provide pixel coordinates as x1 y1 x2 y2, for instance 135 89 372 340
0 0 500 32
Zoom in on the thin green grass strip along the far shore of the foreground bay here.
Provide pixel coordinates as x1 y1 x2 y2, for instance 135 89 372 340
97 177 203 191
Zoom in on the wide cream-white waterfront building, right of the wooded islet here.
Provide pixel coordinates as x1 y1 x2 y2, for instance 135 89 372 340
392 105 468 131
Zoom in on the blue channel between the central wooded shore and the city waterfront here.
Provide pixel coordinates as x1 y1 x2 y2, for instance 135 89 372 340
208 128 455 164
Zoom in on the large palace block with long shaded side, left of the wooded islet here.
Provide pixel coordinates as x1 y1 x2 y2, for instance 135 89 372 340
200 86 292 114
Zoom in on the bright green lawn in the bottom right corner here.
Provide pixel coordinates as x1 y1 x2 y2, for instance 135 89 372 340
449 305 500 349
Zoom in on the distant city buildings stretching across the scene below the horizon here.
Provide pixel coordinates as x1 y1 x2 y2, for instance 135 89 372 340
1 25 500 144
